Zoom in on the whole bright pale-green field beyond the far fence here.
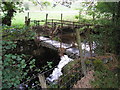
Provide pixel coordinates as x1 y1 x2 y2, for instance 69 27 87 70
12 3 88 25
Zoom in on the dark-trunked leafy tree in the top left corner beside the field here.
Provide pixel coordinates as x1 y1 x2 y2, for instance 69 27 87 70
1 0 50 26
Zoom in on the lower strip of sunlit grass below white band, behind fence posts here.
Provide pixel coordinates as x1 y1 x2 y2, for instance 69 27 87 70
12 11 76 25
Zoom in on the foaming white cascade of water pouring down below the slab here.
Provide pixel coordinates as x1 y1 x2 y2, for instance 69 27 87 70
47 55 73 82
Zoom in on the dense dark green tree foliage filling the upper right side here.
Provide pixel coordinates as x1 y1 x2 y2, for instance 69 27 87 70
83 2 120 55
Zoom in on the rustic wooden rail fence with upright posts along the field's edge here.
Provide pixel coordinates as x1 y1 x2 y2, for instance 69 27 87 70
25 13 98 28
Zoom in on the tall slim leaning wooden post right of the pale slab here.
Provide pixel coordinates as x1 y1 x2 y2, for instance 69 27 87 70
76 29 86 75
